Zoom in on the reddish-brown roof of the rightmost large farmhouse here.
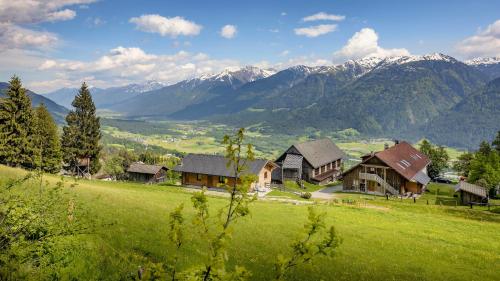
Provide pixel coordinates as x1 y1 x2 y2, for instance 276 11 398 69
375 141 431 180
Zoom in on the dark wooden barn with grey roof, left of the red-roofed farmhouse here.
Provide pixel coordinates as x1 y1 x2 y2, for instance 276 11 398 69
273 139 345 184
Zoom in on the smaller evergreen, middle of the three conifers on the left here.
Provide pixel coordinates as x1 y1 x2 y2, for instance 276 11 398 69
34 104 62 173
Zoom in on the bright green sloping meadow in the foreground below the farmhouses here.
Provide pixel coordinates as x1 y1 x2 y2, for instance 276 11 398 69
0 166 500 280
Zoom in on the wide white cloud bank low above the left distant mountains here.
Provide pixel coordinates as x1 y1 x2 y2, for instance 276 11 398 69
28 46 240 92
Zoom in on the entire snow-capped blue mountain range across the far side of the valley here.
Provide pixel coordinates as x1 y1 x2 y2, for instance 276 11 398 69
35 54 500 147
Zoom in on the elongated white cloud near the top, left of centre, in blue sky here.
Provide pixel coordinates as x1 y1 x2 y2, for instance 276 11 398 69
129 15 202 37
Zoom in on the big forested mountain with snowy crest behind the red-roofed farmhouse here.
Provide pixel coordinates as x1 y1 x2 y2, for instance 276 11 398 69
214 54 487 136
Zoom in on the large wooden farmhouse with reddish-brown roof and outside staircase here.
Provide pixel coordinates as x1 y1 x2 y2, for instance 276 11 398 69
343 141 431 195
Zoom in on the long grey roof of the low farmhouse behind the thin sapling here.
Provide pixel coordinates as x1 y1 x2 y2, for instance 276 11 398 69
173 154 276 177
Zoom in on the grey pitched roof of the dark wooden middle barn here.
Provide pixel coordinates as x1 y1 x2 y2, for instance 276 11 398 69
293 139 345 168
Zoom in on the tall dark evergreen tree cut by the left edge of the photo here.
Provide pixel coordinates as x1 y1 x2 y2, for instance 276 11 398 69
0 75 36 168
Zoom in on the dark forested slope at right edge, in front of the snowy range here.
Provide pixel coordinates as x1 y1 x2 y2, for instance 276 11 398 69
421 75 500 149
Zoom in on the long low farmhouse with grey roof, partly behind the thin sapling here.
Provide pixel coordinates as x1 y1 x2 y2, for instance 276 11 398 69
174 154 276 190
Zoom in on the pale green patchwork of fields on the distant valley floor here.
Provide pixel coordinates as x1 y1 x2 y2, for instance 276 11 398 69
102 119 462 166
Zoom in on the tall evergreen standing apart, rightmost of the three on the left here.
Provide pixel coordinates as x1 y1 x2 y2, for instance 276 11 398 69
61 82 101 174
